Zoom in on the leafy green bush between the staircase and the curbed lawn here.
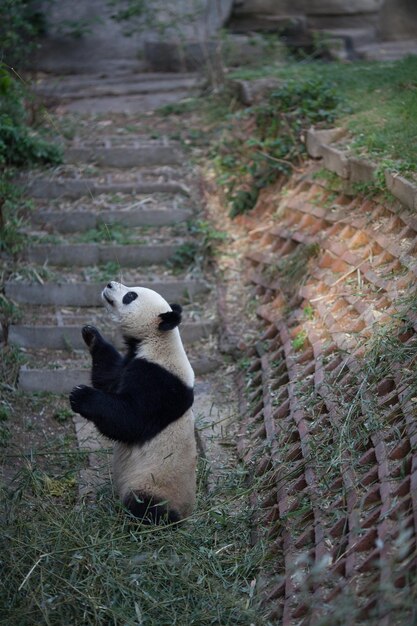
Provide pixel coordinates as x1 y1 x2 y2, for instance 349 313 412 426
215 78 339 217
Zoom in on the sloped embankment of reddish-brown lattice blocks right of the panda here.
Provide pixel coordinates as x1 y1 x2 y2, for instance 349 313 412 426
234 165 417 625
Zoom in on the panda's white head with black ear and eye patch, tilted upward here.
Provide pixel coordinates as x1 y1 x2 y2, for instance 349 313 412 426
101 281 181 341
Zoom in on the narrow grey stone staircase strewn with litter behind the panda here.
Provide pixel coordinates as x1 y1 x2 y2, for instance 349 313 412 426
5 117 216 393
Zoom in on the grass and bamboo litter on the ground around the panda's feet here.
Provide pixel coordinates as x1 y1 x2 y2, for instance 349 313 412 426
0 449 268 626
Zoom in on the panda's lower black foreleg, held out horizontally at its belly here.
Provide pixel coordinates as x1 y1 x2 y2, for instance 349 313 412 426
70 385 139 443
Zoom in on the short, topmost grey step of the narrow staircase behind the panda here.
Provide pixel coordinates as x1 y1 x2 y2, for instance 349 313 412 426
64 141 183 168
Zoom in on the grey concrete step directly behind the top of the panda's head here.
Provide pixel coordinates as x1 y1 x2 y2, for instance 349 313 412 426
5 279 209 307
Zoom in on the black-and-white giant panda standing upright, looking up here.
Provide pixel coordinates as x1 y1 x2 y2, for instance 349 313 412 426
70 282 197 523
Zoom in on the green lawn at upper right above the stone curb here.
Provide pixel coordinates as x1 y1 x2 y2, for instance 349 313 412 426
232 57 417 172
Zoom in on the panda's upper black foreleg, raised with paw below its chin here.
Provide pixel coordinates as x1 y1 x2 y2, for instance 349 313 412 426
81 326 123 391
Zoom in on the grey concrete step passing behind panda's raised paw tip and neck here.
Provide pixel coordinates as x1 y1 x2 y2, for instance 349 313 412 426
8 322 215 350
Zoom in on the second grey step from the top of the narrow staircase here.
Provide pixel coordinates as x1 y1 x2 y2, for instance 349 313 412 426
24 177 188 199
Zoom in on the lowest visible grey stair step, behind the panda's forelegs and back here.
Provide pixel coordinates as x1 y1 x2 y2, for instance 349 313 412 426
18 358 221 394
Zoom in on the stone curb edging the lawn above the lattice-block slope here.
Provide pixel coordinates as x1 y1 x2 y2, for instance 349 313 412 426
306 128 417 211
